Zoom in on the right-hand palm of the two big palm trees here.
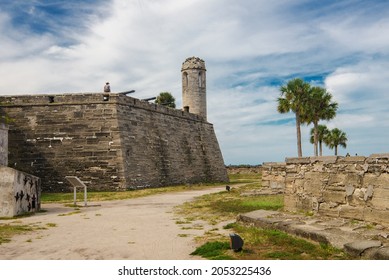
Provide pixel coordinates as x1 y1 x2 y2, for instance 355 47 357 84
303 87 338 156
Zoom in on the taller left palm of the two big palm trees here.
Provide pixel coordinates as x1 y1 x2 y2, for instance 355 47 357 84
277 78 310 157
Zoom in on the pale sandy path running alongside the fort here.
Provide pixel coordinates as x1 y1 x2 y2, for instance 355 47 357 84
0 187 230 260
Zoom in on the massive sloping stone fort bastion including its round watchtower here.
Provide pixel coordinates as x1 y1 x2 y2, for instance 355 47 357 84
0 57 228 192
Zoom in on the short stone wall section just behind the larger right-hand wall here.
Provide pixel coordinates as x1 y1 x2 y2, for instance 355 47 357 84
262 162 286 190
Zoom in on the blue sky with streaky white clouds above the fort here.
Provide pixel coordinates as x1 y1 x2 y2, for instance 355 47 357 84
0 0 389 164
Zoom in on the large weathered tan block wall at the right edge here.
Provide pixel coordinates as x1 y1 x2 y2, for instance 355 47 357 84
284 154 389 224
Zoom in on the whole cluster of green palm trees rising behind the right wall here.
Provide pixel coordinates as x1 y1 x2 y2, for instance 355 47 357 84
277 78 348 157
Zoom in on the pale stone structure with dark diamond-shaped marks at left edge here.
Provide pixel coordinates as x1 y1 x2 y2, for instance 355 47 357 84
0 124 41 217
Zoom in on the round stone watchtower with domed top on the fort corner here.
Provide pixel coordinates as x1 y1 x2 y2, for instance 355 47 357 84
181 57 207 120
